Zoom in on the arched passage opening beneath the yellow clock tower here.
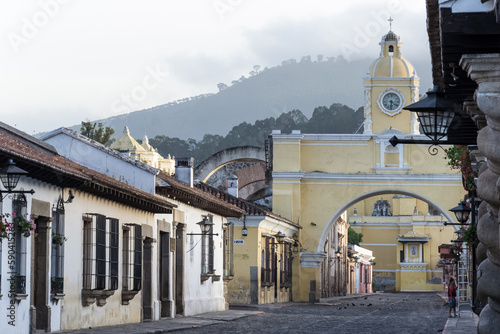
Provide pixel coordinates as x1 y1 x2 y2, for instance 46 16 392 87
316 189 455 297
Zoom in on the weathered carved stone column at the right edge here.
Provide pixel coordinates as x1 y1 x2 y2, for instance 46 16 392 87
460 54 500 334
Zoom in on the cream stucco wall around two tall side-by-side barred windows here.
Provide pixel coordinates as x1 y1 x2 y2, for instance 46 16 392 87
61 191 156 329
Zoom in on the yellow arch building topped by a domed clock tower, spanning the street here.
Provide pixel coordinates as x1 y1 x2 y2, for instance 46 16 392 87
272 31 465 301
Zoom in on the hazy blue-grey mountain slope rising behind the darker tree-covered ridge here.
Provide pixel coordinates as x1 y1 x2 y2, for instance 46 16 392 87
72 56 371 140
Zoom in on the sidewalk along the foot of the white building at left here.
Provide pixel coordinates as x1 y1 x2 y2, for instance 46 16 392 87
55 310 262 334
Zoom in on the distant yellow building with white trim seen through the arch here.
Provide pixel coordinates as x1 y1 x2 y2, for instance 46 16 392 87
347 195 454 292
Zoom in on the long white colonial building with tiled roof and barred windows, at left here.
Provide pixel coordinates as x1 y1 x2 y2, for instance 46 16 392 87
0 123 242 333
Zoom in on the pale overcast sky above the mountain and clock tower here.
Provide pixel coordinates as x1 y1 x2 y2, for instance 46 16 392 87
0 0 430 134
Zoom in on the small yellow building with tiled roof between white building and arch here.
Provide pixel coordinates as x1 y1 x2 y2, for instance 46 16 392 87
195 180 300 304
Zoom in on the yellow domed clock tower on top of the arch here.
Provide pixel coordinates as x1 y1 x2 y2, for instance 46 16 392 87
364 31 419 135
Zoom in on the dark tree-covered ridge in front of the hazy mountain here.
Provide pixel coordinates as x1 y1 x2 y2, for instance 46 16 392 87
149 103 364 165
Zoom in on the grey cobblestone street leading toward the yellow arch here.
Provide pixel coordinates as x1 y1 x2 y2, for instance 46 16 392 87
180 293 448 334
